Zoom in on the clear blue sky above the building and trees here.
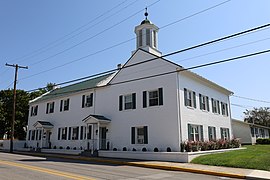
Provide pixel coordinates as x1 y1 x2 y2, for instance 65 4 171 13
0 0 270 120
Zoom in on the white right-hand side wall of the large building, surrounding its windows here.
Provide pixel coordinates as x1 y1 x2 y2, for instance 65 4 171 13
179 72 232 141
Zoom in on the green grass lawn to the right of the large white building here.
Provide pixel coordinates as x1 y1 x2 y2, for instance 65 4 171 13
191 145 270 171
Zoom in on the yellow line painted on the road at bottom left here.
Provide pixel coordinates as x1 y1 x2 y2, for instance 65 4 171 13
0 160 94 180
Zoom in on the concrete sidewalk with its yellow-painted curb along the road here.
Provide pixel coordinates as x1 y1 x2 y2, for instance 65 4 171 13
11 152 270 180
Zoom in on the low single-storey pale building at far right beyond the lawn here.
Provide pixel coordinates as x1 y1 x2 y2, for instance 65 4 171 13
232 119 270 144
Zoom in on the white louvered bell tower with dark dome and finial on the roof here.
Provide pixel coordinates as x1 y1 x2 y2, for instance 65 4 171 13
135 8 161 56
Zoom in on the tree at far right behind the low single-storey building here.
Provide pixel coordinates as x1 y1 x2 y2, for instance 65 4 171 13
244 107 270 127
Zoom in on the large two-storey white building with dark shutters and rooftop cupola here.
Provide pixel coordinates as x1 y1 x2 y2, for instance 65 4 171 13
27 13 232 152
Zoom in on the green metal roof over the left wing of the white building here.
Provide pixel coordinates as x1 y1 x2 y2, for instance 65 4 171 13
30 73 113 103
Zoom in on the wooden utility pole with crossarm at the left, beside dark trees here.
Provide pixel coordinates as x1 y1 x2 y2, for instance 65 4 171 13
6 63 28 153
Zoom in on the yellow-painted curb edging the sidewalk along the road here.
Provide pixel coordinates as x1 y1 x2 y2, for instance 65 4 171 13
12 152 248 179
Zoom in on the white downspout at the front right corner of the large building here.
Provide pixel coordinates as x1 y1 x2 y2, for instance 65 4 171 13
176 72 182 151
